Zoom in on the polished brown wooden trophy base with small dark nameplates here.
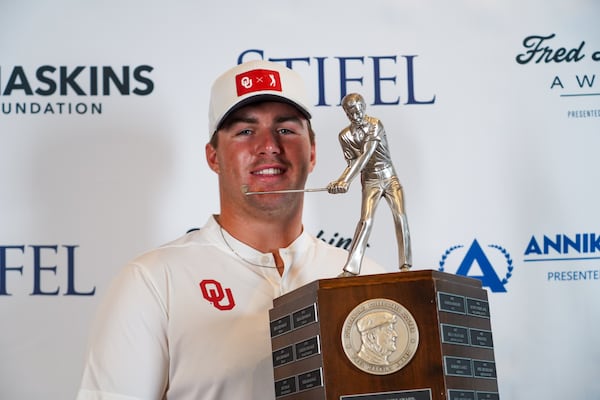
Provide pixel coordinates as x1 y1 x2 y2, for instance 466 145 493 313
270 270 499 400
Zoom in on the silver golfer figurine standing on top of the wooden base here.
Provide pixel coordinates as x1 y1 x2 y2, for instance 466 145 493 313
327 93 412 276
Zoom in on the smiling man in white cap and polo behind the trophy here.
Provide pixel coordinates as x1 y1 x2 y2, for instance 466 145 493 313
78 61 385 400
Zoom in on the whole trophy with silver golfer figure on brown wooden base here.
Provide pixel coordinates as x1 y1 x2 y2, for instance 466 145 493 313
250 93 499 400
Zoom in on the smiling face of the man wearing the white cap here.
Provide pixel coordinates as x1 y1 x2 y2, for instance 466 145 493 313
206 102 315 217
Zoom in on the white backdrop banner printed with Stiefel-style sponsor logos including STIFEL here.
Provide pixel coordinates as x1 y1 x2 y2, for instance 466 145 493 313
0 0 600 400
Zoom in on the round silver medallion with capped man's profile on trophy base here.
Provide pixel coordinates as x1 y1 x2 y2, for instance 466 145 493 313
342 299 419 375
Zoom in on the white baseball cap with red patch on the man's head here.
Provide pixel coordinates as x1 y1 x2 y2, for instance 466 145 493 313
208 60 311 138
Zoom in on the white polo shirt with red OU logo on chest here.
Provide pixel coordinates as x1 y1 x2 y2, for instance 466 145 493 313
77 217 386 400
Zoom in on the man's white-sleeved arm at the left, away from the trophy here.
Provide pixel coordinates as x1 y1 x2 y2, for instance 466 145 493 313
77 264 169 400
